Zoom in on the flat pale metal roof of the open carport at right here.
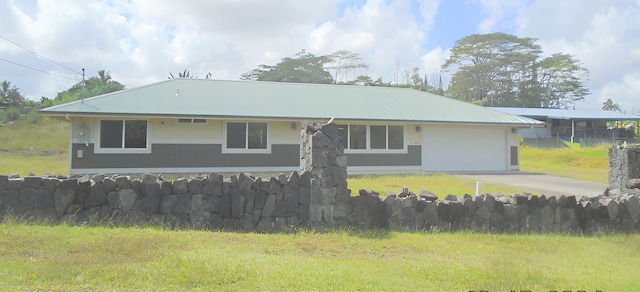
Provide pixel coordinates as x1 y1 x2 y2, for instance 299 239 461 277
491 107 640 121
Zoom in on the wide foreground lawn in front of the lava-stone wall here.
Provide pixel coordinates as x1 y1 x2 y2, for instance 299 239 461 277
0 223 640 291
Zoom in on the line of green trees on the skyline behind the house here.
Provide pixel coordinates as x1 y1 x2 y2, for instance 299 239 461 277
0 33 632 121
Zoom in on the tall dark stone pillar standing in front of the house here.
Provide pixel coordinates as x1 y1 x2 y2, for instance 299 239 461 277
300 123 351 227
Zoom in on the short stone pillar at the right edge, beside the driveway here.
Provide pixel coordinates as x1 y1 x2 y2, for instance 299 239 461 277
609 146 640 192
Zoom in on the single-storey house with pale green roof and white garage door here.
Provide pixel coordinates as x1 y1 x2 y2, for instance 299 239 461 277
41 79 543 174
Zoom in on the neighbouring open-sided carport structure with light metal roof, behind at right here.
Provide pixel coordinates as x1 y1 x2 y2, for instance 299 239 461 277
491 107 640 145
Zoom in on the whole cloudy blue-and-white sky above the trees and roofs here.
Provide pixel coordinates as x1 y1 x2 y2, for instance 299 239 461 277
0 0 640 114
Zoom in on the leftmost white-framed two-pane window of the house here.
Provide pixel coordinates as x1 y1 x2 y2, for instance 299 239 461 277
100 120 147 149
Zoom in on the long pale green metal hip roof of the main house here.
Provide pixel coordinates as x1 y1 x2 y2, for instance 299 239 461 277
40 78 542 126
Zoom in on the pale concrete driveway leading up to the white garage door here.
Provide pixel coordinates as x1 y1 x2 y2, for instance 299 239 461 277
454 172 607 197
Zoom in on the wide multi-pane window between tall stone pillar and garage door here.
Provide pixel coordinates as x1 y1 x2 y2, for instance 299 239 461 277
338 125 405 150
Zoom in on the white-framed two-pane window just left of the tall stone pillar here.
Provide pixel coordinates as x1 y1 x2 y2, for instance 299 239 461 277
227 122 267 150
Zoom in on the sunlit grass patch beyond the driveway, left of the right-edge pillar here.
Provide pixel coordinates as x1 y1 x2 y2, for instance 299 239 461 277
520 146 609 183
